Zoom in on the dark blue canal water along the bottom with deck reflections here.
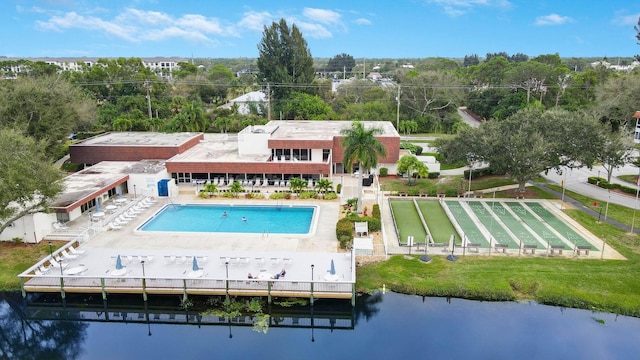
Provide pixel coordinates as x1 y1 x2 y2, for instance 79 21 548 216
0 293 640 360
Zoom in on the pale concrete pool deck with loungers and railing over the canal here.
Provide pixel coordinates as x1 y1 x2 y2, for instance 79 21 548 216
21 193 355 299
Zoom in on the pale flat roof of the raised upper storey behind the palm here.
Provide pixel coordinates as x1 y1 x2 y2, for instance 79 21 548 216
265 120 400 140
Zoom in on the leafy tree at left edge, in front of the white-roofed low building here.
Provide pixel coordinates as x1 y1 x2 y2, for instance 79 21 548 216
0 129 63 233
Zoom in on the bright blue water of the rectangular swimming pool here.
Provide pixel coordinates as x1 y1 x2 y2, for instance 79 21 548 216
137 204 315 234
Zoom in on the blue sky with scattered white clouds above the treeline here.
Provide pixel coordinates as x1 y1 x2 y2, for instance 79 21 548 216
0 0 640 58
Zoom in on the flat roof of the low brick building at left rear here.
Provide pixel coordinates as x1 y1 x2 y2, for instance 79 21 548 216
71 132 201 147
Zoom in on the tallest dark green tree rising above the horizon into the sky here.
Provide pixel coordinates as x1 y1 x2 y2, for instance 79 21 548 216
257 19 315 101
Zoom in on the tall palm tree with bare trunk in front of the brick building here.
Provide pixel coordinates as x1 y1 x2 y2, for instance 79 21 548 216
340 121 387 213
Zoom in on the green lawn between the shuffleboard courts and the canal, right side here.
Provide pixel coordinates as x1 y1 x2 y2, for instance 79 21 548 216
357 186 640 317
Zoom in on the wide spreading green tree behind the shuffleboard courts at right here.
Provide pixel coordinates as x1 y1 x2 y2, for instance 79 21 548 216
436 108 602 192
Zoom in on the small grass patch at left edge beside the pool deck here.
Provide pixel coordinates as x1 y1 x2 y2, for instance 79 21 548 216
0 241 65 291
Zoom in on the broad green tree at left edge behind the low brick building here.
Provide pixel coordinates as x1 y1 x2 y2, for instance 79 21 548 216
0 77 95 158
